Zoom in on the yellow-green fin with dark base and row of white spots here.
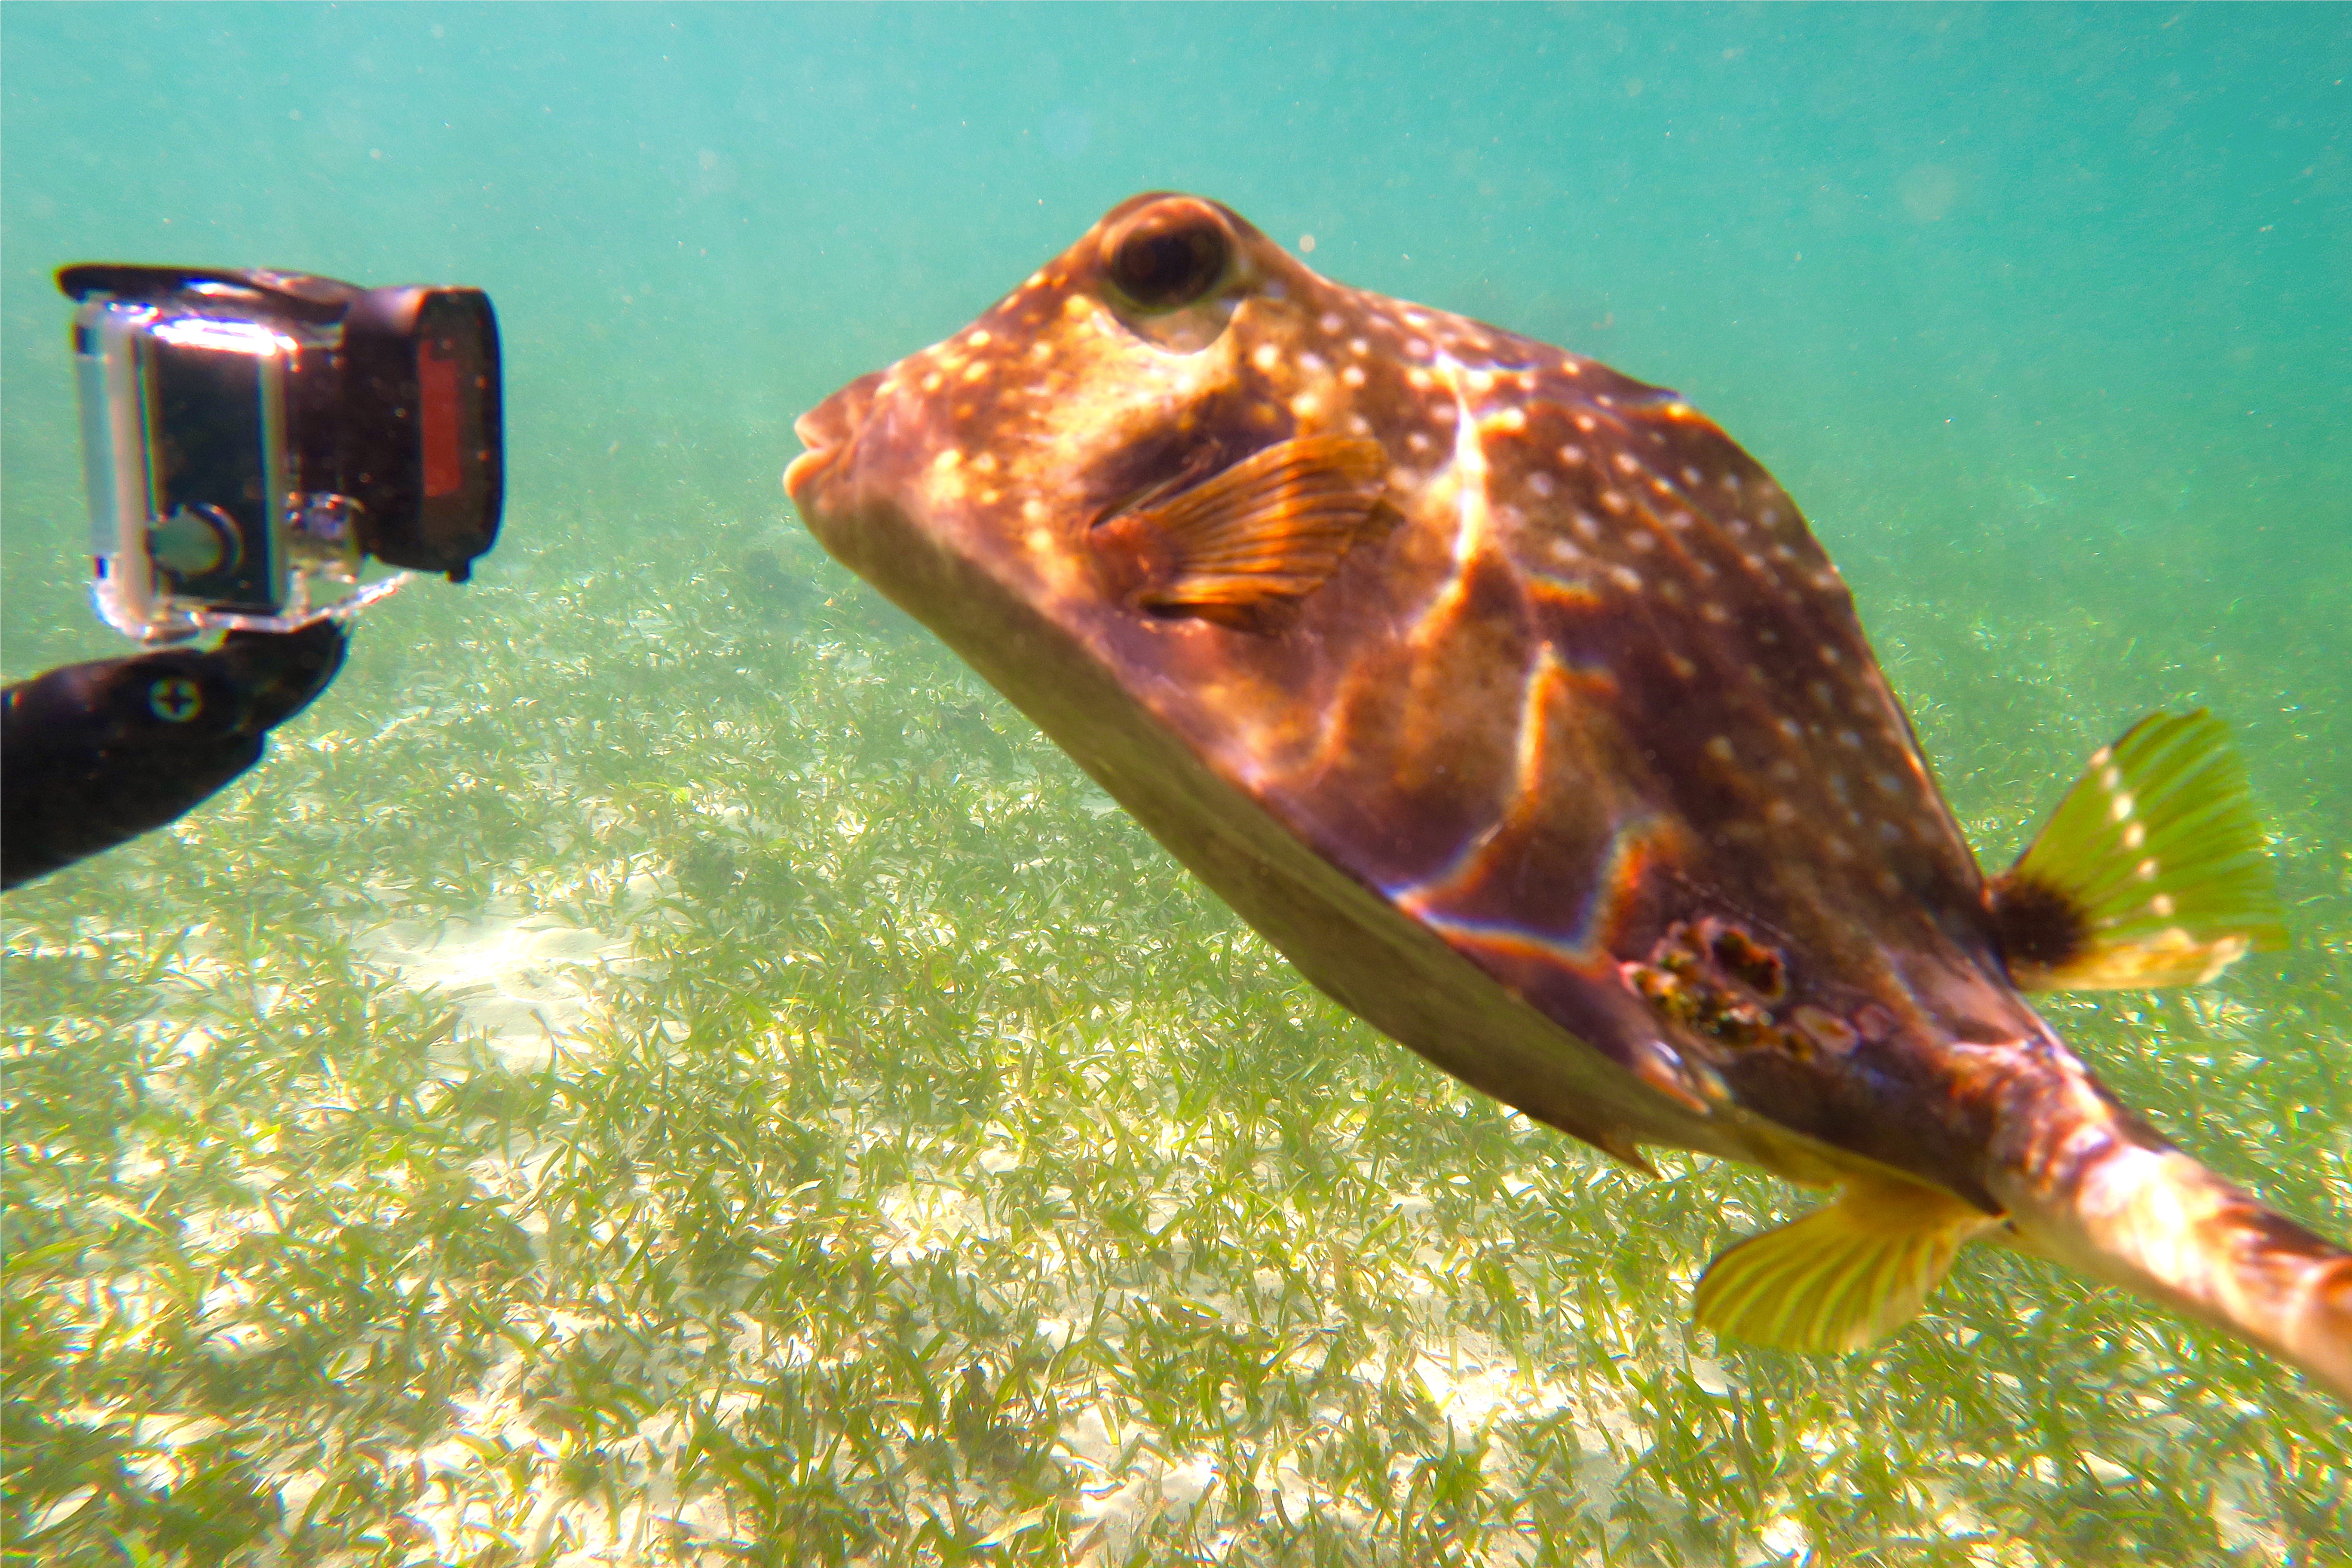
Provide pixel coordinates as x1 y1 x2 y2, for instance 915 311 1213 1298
1985 707 2286 990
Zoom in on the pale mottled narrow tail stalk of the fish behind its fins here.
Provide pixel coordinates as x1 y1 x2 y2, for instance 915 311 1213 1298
1990 1056 2352 1399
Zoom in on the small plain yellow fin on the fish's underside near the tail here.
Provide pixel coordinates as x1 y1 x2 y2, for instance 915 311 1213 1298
1698 1176 1999 1352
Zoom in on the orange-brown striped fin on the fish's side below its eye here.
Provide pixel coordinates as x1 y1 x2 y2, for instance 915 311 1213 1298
1131 435 1387 611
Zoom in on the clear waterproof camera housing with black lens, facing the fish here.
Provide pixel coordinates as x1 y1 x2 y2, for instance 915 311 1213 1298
56 266 505 642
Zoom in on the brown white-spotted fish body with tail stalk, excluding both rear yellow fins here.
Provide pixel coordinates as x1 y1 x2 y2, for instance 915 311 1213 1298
786 195 2352 1392
